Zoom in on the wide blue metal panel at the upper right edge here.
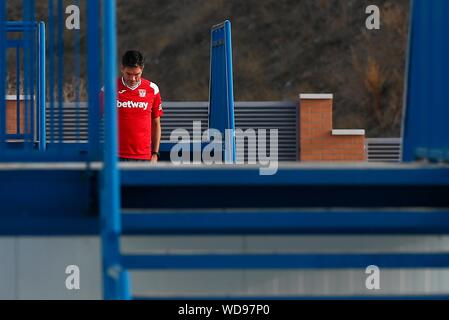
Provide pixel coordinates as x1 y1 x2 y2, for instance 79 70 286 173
403 0 449 161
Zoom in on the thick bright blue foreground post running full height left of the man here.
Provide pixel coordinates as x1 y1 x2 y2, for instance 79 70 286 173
101 0 129 299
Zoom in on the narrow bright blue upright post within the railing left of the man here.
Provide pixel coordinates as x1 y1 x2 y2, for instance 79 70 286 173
38 22 47 151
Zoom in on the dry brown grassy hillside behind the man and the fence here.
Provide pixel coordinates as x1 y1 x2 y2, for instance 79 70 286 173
8 0 410 136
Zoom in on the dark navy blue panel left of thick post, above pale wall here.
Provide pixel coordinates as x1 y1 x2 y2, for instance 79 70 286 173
0 166 100 236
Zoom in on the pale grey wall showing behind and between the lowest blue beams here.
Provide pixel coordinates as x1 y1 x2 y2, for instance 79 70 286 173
0 236 449 299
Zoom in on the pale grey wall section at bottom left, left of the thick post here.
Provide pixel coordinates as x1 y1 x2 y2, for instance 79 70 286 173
0 237 102 299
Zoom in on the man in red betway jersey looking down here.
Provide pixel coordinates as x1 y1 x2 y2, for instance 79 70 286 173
101 50 163 162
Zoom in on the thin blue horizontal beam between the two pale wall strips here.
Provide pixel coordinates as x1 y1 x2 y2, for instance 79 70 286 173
121 253 449 270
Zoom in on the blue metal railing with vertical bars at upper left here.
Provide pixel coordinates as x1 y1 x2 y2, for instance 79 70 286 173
0 0 103 162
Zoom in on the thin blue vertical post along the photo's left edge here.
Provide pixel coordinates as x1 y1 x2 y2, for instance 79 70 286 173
0 0 6 153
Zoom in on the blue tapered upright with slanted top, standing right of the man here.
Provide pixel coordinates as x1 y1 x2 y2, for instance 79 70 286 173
209 20 236 163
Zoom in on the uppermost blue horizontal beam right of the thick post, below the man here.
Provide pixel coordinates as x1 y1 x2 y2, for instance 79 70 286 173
120 165 449 186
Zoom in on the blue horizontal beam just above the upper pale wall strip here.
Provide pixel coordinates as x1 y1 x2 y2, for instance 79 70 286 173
122 209 449 235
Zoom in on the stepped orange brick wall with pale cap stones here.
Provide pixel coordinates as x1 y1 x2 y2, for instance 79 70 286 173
299 94 366 162
